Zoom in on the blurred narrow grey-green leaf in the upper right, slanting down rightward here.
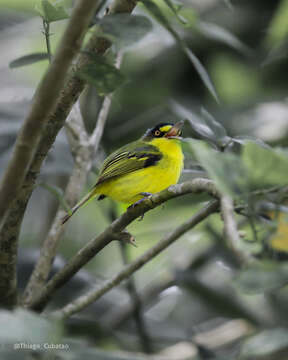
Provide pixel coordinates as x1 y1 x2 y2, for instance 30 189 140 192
197 21 253 56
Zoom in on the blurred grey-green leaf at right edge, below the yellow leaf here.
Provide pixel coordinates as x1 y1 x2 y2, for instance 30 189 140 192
234 262 288 294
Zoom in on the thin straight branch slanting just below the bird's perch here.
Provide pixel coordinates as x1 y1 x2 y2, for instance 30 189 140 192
53 200 219 319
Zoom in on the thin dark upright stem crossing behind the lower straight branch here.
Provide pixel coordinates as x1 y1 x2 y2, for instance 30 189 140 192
119 241 152 354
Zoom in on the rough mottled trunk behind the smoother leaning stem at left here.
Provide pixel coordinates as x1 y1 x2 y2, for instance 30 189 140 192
0 0 136 310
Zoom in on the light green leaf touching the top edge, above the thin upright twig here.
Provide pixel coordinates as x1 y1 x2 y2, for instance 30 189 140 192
35 0 69 23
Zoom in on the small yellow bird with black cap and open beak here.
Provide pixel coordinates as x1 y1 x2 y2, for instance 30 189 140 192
62 121 184 224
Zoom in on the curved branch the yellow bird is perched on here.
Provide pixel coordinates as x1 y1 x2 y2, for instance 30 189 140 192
29 179 219 310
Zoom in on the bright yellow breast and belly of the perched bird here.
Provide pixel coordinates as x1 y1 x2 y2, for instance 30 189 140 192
96 138 183 204
